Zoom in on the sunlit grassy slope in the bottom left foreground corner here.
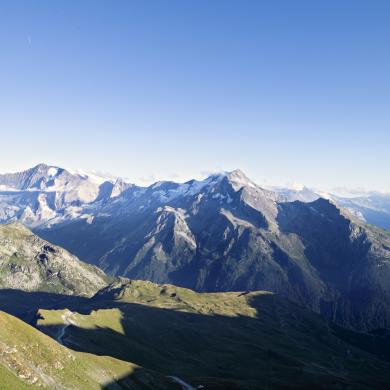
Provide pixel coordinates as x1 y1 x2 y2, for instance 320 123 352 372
0 312 180 390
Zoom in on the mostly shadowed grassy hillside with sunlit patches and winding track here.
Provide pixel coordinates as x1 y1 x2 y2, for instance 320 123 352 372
37 280 390 389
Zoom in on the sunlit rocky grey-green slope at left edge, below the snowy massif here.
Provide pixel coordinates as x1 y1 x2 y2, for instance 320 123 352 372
0 222 110 296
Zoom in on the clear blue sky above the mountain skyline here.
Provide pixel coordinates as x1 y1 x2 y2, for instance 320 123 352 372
0 0 390 190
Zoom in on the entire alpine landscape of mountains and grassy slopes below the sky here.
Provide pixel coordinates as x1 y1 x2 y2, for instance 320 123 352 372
0 164 390 389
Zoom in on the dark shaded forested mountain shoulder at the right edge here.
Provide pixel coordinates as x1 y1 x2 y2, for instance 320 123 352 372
279 199 390 329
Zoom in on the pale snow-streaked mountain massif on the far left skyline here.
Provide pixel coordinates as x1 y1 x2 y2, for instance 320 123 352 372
0 164 129 227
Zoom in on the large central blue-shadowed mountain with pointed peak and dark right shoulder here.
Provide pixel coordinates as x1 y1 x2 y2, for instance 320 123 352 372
35 171 390 329
